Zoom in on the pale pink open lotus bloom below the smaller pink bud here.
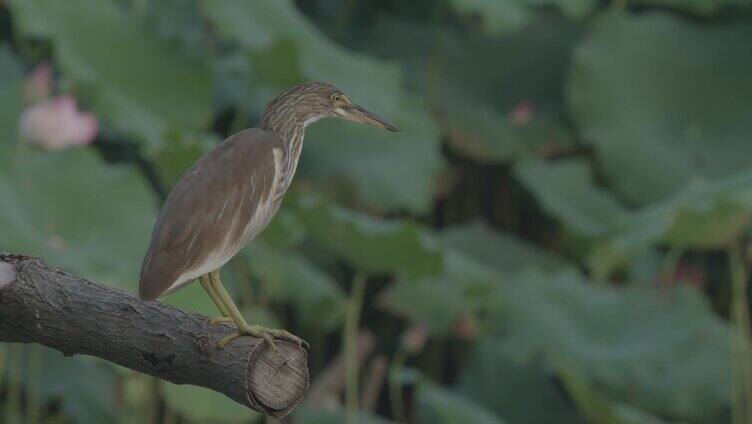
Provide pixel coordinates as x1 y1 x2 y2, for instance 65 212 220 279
21 95 99 150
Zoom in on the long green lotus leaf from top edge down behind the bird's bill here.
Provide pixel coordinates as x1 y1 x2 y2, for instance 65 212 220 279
202 0 443 212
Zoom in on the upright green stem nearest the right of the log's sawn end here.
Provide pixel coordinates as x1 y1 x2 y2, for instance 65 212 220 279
343 273 366 424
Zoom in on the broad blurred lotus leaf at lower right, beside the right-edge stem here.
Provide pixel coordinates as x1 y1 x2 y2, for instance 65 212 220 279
496 273 731 419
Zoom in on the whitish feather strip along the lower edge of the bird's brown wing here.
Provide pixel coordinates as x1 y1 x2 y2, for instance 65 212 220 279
165 149 282 293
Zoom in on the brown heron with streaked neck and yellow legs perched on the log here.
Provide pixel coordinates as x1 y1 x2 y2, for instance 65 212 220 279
139 82 400 350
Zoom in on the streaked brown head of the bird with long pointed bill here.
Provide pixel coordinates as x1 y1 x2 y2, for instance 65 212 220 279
259 82 400 132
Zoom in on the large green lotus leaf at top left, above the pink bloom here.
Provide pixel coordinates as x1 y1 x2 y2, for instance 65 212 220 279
10 0 212 152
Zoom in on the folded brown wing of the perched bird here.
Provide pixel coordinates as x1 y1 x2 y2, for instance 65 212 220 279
139 129 284 299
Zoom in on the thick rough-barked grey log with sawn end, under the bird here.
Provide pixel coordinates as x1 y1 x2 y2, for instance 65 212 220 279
0 252 308 417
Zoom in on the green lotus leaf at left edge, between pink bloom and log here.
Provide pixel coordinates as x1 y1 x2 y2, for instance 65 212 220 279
0 149 155 289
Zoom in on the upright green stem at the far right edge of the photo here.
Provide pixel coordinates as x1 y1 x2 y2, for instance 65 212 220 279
728 244 752 423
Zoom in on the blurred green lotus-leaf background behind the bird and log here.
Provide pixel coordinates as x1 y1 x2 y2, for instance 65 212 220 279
0 0 752 424
